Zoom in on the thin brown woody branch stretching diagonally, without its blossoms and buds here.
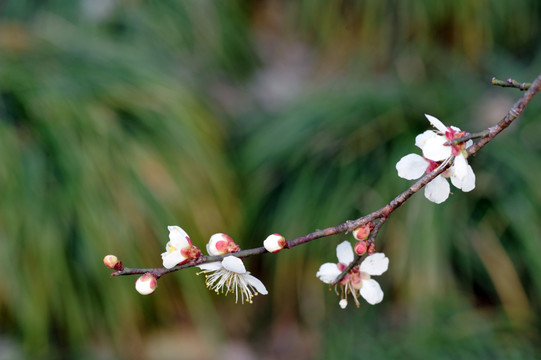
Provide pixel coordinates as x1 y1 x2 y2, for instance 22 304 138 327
111 75 541 283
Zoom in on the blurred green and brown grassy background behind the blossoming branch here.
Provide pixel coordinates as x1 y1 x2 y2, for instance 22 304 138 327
0 0 541 360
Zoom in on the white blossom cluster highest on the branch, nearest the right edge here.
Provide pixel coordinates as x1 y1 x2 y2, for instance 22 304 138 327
396 114 475 204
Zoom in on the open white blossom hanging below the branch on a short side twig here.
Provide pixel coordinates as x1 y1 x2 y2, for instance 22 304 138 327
316 241 389 309
